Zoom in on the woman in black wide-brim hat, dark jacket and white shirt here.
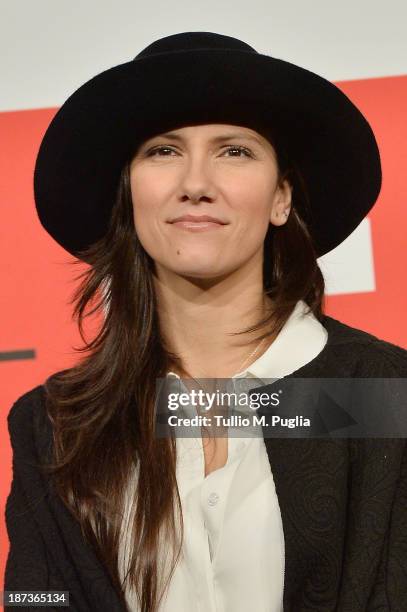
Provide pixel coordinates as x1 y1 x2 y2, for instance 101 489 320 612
5 32 407 612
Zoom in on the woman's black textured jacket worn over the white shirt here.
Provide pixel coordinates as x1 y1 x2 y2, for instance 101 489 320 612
4 316 407 612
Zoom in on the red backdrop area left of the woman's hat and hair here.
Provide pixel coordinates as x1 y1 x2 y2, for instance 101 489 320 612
0 109 100 588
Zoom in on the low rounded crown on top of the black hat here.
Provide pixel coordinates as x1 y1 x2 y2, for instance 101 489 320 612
134 32 257 60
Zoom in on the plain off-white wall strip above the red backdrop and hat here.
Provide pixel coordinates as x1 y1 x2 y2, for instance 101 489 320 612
0 0 407 111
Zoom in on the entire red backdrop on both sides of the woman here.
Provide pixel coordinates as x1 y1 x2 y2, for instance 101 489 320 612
0 76 407 588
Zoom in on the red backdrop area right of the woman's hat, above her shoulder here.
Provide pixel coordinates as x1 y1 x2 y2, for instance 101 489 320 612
326 76 407 348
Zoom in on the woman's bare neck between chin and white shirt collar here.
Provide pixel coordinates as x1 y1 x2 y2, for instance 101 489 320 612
155 262 274 378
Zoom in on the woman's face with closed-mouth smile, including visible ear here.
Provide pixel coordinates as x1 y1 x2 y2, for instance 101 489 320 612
130 124 291 278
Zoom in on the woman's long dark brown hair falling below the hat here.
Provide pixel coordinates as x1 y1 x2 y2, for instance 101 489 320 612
38 126 324 612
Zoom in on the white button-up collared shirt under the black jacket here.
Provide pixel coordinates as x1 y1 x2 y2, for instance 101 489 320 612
119 301 327 612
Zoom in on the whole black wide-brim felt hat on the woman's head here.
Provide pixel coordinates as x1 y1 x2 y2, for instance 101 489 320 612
34 32 381 256
